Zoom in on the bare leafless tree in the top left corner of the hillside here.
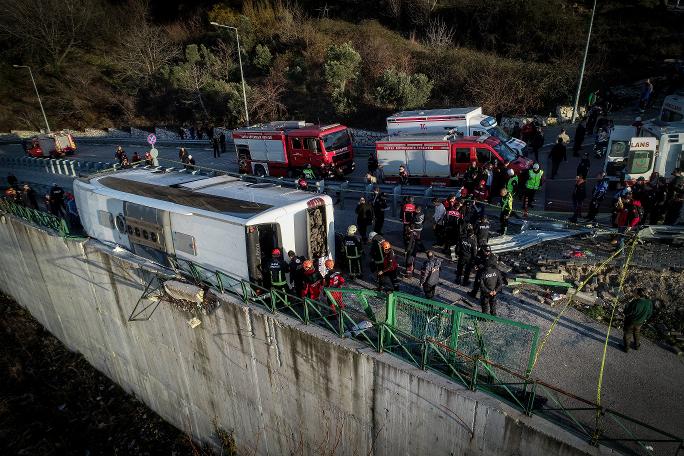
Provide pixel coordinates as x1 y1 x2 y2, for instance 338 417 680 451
0 0 103 66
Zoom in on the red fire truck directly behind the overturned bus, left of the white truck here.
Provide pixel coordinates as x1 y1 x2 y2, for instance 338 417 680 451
233 121 355 178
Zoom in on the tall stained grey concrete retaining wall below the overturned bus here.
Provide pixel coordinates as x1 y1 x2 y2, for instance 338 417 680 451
0 216 609 456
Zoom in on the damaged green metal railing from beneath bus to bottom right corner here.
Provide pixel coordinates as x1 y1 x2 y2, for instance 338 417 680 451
171 258 684 455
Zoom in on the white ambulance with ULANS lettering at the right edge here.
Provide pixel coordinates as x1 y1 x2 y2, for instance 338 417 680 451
604 122 684 184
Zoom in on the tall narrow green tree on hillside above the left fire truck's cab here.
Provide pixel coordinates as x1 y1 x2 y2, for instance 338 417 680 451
323 42 361 114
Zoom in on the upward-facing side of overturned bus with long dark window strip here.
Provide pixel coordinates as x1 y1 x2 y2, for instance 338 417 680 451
90 169 322 221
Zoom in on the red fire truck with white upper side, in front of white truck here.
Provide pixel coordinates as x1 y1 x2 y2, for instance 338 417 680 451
375 134 532 186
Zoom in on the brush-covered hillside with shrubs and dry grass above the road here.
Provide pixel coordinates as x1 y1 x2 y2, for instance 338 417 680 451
0 0 684 131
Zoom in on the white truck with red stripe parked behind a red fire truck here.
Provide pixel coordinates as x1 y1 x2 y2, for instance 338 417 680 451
387 107 526 154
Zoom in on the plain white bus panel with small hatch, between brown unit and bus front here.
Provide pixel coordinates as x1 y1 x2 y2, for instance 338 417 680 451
170 213 249 280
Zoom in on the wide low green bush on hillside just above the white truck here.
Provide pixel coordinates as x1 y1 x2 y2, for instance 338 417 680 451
375 68 433 109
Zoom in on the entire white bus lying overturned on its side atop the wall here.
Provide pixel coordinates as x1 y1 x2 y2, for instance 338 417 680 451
74 169 335 283
